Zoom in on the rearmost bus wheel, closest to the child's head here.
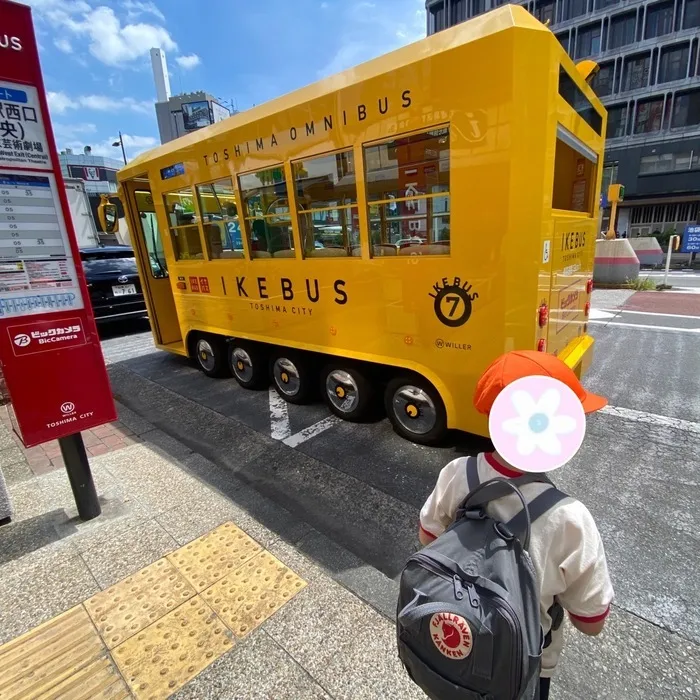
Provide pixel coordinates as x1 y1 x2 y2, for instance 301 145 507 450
384 375 447 445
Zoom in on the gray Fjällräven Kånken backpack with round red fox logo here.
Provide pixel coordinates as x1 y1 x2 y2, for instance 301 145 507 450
397 457 566 700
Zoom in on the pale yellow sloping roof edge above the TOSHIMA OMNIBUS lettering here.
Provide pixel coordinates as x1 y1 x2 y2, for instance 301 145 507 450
118 5 550 181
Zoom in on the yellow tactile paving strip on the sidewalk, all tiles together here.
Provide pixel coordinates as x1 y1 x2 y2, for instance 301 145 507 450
0 523 306 700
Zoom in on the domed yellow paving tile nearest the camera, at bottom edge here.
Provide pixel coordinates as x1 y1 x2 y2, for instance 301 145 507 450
112 597 233 700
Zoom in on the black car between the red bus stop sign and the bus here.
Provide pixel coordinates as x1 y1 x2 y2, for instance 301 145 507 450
80 245 147 323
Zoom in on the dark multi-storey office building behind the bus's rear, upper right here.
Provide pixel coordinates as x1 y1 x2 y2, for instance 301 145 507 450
426 0 700 236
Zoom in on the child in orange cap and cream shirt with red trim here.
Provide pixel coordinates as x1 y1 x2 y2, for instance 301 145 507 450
419 351 613 700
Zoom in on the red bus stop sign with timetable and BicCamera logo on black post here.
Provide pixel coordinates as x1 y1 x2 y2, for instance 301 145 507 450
0 0 116 520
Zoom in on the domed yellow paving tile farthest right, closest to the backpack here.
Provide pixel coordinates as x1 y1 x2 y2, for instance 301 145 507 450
202 552 306 637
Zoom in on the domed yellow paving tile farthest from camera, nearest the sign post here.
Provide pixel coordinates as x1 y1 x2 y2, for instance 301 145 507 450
168 523 262 592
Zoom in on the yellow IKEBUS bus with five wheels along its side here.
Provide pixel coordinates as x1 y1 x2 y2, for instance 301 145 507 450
119 5 606 444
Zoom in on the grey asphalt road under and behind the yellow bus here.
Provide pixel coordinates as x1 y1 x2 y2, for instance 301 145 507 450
103 292 700 700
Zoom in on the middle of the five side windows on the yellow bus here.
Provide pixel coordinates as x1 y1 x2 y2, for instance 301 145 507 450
238 165 294 258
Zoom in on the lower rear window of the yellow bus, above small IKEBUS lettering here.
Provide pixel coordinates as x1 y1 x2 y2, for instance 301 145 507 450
552 124 598 216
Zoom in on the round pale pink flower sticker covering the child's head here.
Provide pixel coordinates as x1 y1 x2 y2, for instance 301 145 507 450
489 376 586 473
